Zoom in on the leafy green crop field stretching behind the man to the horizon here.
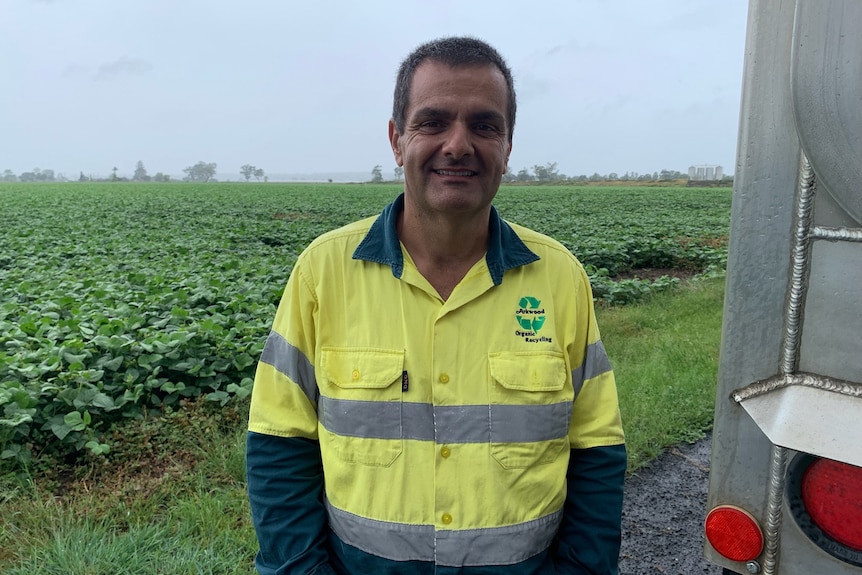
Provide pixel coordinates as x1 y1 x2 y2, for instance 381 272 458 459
0 183 731 469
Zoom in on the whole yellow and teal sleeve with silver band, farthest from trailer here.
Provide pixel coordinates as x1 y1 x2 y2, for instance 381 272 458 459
246 253 335 575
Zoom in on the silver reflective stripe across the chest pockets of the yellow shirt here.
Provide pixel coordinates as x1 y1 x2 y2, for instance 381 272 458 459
319 396 572 443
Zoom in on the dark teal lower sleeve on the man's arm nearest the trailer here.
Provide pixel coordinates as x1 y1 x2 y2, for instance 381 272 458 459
554 445 627 575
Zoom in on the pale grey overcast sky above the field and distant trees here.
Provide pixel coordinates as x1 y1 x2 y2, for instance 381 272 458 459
0 0 748 177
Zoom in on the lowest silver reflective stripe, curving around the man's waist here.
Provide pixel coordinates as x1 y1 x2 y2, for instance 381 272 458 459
326 500 563 567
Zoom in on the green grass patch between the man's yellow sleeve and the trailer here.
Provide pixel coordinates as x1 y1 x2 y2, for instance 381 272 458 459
597 277 724 472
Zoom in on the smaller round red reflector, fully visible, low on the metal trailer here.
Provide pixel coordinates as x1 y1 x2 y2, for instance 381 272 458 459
704 505 763 561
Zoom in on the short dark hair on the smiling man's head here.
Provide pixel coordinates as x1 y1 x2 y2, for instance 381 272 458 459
392 36 517 142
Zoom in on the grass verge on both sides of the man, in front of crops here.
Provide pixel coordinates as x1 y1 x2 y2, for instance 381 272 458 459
0 278 724 575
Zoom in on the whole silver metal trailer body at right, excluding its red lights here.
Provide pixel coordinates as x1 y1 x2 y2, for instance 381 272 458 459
704 0 862 575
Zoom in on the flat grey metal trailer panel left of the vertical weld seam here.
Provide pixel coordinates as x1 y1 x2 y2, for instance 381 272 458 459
704 0 800 573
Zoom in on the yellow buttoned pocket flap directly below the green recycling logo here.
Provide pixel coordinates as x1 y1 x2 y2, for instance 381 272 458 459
488 351 566 391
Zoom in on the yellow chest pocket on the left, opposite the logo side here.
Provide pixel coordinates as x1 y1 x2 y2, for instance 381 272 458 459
318 348 404 466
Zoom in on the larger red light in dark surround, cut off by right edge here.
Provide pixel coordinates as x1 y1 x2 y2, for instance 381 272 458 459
802 459 862 551
